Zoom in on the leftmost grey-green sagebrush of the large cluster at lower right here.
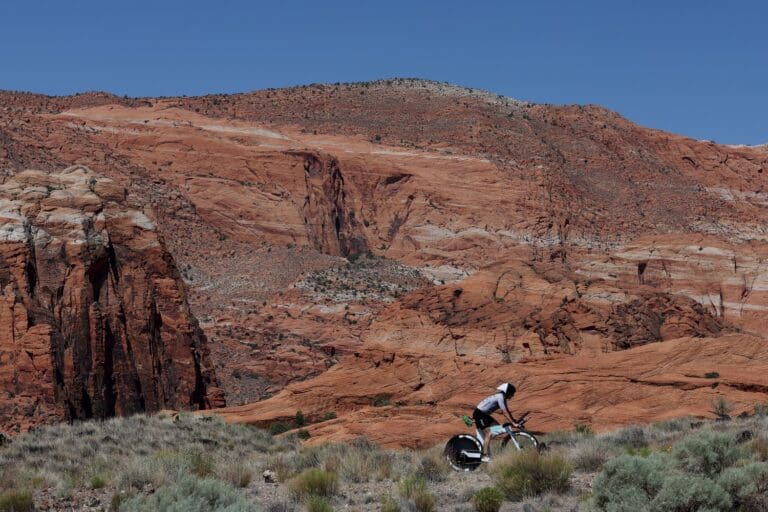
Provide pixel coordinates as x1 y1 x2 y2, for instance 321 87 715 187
590 455 667 512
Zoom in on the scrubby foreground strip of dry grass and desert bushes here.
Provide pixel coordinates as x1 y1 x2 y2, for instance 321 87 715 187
0 408 768 512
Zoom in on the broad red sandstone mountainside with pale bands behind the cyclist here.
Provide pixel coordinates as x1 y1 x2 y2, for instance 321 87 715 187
0 80 768 445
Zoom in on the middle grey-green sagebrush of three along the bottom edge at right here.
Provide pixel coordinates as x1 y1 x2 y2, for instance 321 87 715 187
651 473 731 512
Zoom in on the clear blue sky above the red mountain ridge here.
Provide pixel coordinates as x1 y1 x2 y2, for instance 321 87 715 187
0 0 768 144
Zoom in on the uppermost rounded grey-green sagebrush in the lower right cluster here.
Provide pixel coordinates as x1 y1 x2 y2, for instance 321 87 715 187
672 432 744 477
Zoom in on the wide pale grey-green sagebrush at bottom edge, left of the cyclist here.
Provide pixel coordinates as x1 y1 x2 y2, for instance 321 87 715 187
120 476 253 512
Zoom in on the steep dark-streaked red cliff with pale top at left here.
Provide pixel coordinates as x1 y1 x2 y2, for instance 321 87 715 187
0 166 223 431
